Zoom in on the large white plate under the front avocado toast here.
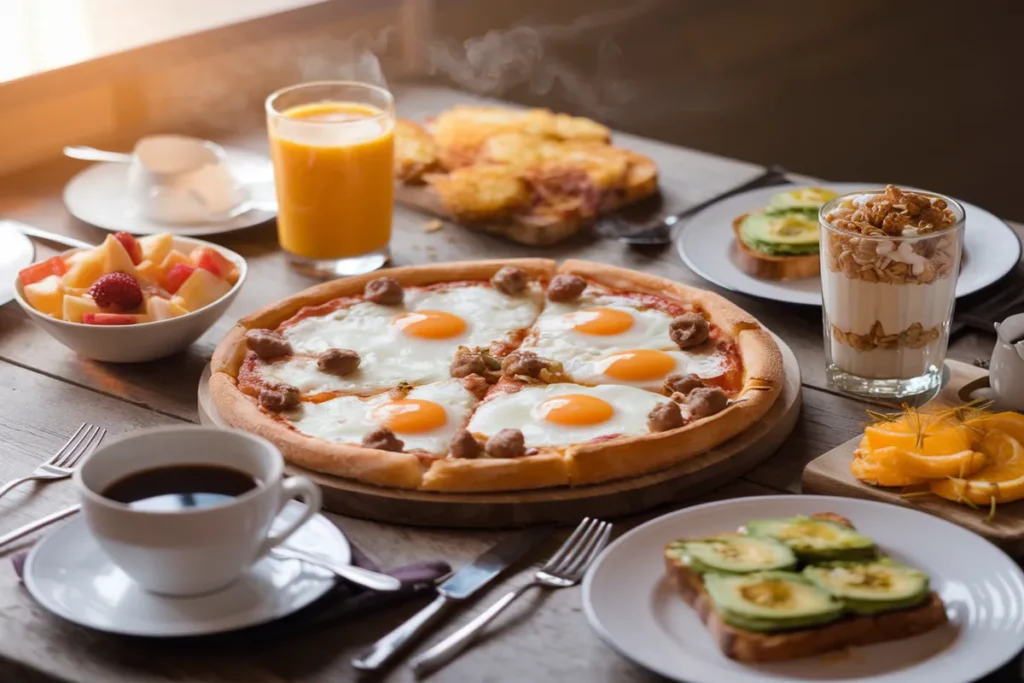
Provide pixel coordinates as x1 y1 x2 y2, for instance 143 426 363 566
583 496 1024 683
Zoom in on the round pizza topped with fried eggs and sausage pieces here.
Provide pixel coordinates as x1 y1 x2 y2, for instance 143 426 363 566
210 259 782 492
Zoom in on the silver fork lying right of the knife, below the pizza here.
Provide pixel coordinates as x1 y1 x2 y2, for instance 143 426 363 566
410 517 611 677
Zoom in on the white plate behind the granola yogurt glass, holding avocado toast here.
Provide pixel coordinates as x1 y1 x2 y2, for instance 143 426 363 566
676 182 1021 306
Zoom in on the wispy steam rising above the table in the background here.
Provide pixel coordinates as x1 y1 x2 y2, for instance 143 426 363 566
146 0 655 129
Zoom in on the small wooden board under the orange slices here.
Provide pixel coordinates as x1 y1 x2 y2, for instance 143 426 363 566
802 360 1024 557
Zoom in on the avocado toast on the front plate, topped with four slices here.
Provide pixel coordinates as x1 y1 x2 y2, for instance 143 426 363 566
665 513 946 663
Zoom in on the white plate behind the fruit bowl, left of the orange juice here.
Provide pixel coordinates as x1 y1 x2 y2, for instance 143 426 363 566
65 147 276 238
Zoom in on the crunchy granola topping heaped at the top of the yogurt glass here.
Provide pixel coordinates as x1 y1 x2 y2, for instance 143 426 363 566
825 185 959 285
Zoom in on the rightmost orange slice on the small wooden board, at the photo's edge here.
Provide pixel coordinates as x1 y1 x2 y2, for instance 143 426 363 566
931 430 1024 505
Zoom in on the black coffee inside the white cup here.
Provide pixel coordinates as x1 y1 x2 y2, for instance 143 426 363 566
103 465 259 512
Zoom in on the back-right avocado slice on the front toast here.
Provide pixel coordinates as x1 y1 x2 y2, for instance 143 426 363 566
740 517 878 562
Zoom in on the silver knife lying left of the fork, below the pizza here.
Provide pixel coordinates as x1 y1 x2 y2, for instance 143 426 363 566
352 527 552 671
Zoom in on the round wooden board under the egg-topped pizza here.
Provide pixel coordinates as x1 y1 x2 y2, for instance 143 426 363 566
199 337 801 528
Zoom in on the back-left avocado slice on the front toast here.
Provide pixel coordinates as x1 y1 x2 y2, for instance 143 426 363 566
669 536 797 573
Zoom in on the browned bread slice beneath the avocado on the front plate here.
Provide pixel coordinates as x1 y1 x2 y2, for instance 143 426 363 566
666 513 947 663
